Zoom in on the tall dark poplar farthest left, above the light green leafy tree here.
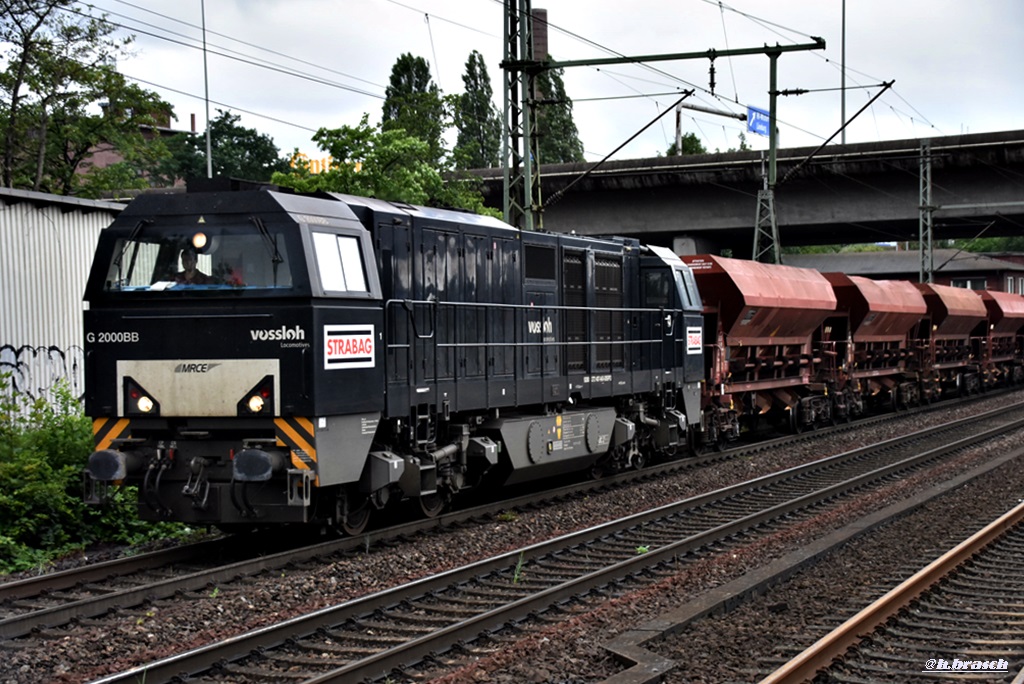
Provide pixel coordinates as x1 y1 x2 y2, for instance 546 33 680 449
381 52 449 165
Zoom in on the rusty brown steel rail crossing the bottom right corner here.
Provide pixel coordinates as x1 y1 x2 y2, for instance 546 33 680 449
760 503 1024 684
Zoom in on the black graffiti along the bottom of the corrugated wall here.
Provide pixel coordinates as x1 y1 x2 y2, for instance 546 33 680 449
0 344 85 399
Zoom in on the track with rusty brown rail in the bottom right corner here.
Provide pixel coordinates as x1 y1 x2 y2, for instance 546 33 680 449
762 504 1024 684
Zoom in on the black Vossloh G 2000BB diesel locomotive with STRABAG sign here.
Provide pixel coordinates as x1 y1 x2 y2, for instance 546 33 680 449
85 188 705 533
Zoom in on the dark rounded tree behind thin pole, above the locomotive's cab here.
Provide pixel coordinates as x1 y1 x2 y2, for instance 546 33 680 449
150 110 289 185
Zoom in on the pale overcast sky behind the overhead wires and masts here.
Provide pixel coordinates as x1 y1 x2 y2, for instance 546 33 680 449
81 0 1024 161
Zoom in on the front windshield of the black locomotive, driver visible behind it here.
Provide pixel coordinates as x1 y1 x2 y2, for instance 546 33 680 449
103 223 293 292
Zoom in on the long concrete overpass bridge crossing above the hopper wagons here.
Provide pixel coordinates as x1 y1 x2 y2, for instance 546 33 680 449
479 130 1024 257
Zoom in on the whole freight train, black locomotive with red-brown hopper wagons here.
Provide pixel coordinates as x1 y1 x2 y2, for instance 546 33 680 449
84 187 1024 535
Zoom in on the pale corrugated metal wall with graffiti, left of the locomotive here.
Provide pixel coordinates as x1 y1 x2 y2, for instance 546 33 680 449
0 188 123 399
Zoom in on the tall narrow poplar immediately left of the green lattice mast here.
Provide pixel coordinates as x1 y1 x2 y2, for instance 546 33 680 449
453 50 502 169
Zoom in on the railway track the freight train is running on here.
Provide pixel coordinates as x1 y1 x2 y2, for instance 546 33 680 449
0 389 958 639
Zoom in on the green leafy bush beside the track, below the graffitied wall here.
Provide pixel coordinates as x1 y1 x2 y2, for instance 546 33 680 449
0 375 187 572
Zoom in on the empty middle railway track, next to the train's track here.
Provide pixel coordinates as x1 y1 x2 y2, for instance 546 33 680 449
77 407 1024 684
